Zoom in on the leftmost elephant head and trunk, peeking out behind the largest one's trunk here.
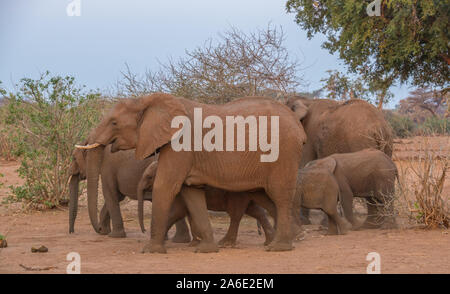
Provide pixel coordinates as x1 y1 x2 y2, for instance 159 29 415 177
69 149 86 233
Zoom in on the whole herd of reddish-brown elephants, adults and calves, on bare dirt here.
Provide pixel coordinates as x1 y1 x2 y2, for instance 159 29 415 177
69 93 397 253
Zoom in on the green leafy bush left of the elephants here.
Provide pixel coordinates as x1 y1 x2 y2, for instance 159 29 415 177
3 72 103 208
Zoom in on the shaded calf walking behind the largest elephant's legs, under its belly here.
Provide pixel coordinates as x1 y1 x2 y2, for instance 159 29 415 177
137 161 276 246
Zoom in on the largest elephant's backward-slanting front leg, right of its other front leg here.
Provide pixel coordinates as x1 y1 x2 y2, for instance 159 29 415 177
181 186 219 253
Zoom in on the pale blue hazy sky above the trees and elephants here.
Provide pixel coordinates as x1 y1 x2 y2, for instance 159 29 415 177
0 0 409 107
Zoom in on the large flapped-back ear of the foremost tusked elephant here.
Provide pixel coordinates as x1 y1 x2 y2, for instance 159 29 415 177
136 94 187 160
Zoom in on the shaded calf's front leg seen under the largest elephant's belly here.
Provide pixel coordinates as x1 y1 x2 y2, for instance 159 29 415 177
219 193 248 247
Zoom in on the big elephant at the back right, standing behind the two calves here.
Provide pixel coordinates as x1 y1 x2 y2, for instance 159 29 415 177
286 96 393 224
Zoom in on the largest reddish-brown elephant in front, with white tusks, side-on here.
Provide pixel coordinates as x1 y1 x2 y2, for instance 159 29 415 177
75 93 306 253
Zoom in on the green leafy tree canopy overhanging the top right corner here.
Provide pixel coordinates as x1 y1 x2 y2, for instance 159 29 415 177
286 0 450 108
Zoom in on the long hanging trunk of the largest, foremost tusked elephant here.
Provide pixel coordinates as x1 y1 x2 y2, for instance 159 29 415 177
87 147 104 233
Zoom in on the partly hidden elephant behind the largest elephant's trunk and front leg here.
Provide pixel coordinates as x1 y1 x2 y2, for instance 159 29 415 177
69 146 191 242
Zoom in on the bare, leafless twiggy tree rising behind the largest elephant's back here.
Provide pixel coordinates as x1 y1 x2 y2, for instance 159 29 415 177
118 25 302 103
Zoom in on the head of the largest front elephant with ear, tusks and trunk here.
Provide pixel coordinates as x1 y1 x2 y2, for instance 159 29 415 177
76 94 186 232
